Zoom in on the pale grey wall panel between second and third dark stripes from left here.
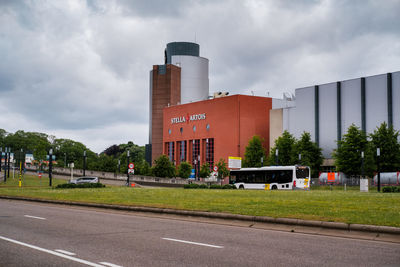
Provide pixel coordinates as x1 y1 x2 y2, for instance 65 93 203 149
341 79 361 136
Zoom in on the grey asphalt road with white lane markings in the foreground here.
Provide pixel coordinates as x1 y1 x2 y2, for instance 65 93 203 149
0 200 400 266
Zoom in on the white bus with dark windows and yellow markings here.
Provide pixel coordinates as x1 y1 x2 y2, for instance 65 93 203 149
229 165 311 190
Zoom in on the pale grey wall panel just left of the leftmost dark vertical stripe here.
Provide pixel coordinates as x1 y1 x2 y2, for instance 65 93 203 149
291 86 315 141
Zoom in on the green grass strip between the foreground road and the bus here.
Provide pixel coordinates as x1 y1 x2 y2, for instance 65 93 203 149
0 175 400 227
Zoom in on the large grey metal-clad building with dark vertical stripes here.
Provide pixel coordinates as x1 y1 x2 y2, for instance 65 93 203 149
270 72 400 159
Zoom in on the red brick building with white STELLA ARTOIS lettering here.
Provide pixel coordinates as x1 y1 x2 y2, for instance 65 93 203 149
162 95 272 169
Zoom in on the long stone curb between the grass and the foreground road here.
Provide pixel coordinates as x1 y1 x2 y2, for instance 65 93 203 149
0 196 400 235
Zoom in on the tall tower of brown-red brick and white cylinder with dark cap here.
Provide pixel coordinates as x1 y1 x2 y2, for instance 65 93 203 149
146 42 209 164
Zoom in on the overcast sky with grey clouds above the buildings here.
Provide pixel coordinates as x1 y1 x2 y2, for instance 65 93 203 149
0 0 400 153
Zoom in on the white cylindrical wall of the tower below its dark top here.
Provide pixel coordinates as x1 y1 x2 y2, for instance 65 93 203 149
171 55 209 104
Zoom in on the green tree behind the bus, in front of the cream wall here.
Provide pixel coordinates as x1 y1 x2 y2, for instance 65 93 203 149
267 131 296 166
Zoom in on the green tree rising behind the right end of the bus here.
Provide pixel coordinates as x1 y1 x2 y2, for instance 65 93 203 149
292 132 324 177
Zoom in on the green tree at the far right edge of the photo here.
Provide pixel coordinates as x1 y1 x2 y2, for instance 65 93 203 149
370 122 400 172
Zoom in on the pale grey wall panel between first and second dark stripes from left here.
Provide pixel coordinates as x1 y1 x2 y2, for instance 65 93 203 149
319 83 337 158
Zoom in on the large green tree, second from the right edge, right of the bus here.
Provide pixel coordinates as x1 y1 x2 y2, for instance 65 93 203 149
332 124 374 176
